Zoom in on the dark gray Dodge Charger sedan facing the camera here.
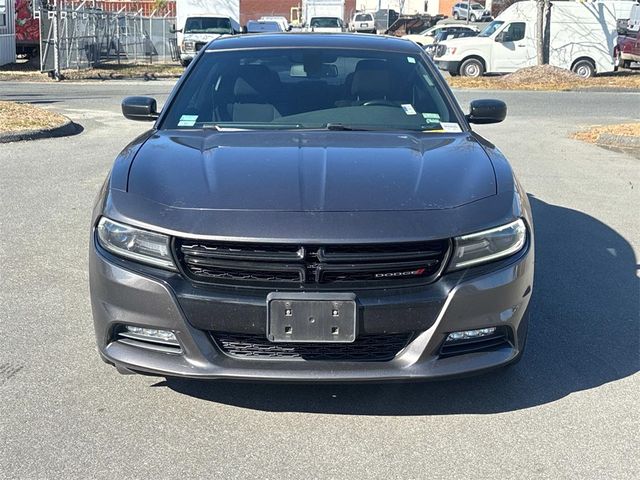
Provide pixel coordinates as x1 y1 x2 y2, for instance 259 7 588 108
90 34 534 381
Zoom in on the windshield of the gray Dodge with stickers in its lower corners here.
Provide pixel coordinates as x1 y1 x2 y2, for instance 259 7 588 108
160 47 460 131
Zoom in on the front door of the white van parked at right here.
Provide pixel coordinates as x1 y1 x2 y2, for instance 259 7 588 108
490 22 536 73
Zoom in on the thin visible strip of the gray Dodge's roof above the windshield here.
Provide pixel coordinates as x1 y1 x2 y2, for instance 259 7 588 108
207 32 422 54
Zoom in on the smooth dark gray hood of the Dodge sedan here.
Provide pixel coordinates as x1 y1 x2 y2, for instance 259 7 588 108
127 130 496 212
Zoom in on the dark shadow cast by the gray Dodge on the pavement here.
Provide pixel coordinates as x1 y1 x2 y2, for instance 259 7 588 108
161 197 640 415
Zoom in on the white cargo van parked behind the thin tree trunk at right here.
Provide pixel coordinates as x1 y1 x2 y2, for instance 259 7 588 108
434 1 627 77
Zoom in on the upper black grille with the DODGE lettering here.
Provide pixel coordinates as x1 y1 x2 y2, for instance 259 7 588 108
174 239 450 288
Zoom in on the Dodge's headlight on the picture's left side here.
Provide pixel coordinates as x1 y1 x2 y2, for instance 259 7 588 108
98 217 176 270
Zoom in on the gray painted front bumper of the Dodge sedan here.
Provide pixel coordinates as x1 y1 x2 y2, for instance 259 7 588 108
90 237 533 381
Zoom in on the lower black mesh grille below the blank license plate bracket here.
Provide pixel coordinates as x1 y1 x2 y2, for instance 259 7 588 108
211 332 411 362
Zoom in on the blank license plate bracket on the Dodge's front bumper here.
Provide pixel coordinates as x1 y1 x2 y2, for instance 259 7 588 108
267 292 357 343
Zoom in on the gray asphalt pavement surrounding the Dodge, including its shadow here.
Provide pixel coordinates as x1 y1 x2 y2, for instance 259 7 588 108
0 82 640 479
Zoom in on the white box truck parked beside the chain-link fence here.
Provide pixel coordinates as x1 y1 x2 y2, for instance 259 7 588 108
174 0 241 66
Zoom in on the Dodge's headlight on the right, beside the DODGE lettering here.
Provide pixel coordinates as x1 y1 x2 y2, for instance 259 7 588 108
449 219 527 270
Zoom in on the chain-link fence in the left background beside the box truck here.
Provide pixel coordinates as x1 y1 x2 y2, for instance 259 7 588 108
35 0 179 75
